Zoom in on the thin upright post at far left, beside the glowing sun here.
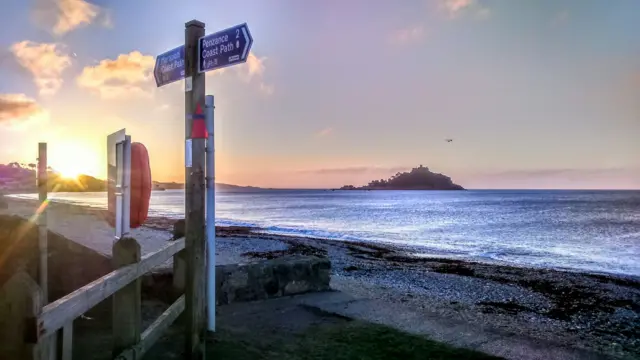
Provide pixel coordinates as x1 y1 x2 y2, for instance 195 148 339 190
36 143 49 305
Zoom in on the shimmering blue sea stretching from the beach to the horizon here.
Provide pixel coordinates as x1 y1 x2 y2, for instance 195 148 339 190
8 190 640 277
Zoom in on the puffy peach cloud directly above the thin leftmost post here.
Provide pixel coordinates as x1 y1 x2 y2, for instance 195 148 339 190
11 41 71 95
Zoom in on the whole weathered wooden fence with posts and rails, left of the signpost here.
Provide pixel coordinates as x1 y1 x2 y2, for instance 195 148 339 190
2 238 192 360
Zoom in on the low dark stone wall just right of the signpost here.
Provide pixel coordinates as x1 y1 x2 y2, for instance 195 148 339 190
216 256 331 304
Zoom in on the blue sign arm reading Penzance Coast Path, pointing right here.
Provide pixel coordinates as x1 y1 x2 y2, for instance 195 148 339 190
198 24 253 72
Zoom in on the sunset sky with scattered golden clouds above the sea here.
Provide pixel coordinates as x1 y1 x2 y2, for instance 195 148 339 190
0 0 640 189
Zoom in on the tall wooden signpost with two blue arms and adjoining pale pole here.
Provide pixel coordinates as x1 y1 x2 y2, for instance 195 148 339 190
153 20 253 359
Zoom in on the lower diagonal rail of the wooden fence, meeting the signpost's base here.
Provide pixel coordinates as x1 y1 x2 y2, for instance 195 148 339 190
115 295 185 360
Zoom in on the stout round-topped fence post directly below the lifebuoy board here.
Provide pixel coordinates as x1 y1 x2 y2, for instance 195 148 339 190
111 238 142 357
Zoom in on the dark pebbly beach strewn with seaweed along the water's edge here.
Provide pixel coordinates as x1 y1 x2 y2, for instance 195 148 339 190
2 198 640 358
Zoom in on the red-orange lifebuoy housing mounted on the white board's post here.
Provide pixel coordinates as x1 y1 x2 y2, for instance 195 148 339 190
107 142 152 229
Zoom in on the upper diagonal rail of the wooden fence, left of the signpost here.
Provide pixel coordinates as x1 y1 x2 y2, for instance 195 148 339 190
36 239 185 339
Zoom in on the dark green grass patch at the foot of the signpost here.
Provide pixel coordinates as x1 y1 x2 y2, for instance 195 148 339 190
207 321 499 360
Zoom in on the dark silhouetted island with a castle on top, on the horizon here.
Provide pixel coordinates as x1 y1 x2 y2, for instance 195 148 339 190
338 165 465 190
